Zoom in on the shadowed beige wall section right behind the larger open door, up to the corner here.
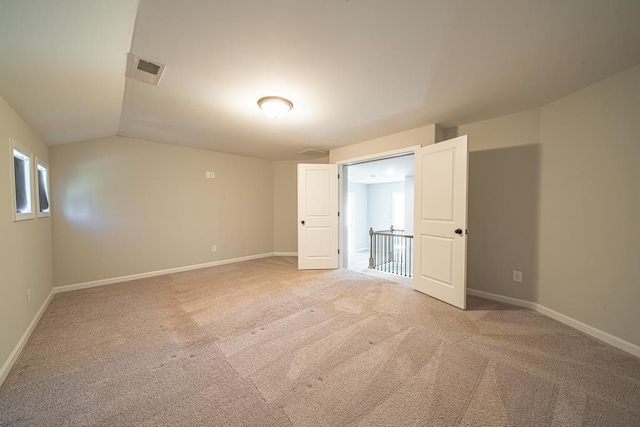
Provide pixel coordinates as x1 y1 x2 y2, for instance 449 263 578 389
445 109 540 301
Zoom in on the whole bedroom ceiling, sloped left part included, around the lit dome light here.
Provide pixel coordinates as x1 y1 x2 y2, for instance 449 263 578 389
0 0 640 159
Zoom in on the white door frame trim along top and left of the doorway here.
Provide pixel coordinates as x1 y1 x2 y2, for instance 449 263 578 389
335 145 422 268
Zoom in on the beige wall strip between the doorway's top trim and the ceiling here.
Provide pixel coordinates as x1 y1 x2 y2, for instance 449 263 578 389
329 125 442 163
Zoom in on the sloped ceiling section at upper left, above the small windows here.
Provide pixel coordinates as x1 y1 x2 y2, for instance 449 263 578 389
0 0 138 145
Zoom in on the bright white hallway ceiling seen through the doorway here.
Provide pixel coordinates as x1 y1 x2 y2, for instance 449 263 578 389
347 154 414 184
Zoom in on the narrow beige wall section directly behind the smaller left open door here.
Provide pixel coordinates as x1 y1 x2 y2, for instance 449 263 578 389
273 157 329 253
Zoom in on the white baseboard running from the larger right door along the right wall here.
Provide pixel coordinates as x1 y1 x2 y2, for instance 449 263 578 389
467 288 640 357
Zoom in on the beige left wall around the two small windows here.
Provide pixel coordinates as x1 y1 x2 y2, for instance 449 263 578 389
0 97 56 378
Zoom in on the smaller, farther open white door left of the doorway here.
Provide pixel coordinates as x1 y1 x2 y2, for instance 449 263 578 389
298 164 339 270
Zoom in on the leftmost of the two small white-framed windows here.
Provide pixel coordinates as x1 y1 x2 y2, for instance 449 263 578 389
11 139 34 221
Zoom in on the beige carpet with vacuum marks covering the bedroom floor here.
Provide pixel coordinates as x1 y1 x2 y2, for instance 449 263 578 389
0 257 640 426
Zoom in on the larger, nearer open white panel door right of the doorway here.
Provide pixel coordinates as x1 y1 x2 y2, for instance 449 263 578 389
413 135 468 309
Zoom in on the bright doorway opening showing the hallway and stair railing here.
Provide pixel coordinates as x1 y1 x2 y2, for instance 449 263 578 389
342 154 414 284
